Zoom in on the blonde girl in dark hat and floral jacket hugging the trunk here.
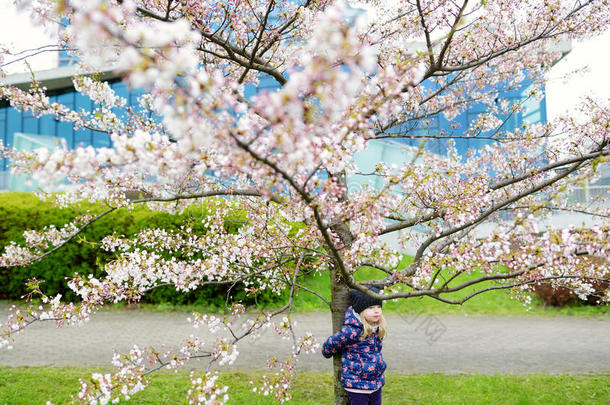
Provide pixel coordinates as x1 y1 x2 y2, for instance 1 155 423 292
322 287 386 405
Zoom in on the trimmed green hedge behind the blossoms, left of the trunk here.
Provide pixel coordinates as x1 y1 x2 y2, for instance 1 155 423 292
0 193 277 308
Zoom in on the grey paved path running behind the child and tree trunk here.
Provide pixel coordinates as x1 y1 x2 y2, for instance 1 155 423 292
0 307 610 374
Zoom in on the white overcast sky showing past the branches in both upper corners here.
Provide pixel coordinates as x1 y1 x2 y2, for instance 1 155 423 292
0 0 610 119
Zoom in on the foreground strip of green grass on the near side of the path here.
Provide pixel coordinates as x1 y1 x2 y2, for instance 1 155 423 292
0 367 610 405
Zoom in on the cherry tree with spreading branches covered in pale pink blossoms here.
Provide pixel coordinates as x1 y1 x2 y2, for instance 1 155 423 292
0 0 610 404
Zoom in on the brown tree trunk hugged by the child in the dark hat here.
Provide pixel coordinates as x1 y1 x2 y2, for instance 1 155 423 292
330 262 349 405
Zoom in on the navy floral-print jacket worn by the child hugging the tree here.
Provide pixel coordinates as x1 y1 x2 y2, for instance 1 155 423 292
322 307 386 390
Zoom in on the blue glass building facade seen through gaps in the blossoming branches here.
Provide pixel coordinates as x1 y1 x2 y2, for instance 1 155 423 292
0 64 610 211
